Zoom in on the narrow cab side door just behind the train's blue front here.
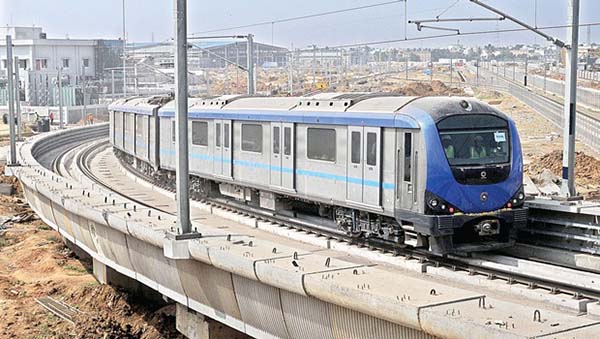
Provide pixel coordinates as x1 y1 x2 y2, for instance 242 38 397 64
397 132 416 210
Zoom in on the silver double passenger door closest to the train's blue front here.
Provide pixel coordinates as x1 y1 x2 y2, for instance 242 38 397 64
346 126 381 206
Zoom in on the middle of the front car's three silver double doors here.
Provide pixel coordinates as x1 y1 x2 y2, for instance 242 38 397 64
269 122 295 190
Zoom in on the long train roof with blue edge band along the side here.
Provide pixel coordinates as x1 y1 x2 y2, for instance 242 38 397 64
109 93 507 128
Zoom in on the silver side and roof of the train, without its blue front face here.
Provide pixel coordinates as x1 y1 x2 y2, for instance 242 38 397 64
110 93 520 254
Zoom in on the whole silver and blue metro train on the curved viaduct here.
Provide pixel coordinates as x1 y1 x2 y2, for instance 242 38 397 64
109 93 527 255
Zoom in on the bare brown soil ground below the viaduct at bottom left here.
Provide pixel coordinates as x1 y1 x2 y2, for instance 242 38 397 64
0 168 182 339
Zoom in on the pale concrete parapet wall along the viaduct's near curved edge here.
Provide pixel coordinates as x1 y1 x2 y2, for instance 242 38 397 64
14 127 600 338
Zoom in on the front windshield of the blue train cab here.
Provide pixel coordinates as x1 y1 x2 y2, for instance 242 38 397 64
438 114 510 166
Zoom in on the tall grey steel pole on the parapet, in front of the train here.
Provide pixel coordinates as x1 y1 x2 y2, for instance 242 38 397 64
174 0 191 234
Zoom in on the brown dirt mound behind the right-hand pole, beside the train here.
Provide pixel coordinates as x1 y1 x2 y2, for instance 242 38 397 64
525 150 600 200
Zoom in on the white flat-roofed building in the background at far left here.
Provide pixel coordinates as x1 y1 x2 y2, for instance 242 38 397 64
0 26 123 106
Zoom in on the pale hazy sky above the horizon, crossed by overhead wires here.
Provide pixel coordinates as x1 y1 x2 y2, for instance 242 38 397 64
0 0 600 48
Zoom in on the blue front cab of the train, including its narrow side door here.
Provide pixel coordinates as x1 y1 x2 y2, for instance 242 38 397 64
396 99 527 255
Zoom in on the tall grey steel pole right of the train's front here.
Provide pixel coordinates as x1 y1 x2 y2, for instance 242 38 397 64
561 0 579 197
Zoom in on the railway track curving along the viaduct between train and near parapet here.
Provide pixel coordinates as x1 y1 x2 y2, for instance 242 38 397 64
59 138 600 308
